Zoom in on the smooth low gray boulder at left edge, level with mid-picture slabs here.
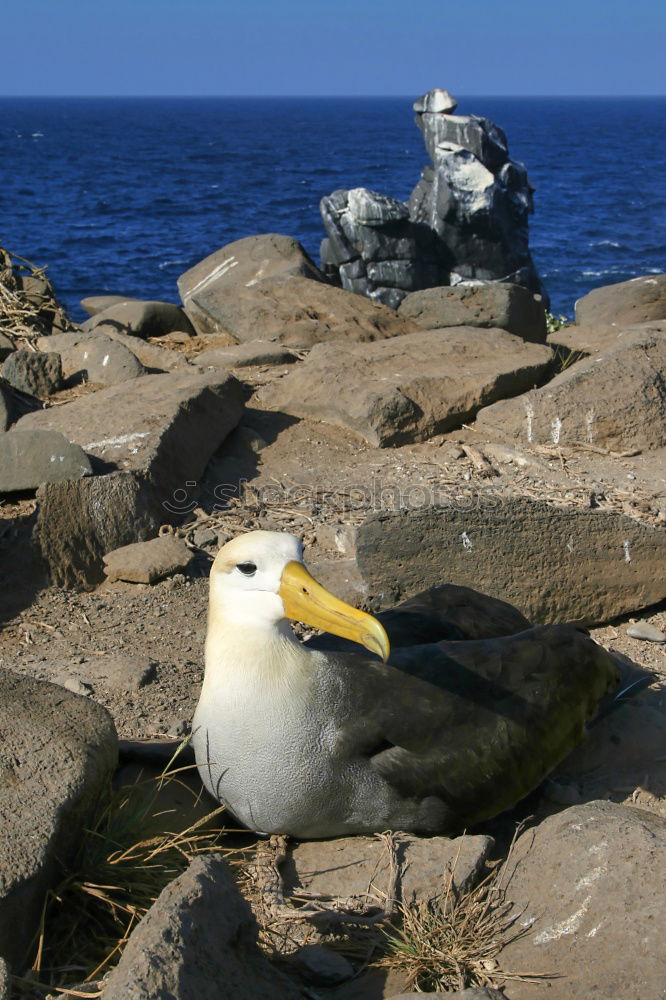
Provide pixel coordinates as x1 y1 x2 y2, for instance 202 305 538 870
0 430 92 493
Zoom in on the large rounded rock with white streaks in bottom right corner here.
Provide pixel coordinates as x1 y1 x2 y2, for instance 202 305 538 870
499 801 666 1000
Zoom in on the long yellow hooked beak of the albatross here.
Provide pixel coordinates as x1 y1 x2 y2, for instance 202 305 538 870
280 562 391 663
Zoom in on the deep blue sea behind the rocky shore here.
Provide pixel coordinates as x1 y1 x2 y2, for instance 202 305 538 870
0 97 666 317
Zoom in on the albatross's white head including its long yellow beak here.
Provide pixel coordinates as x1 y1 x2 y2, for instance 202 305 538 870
210 531 389 660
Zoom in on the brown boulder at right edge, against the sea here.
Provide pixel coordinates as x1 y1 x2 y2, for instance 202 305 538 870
576 274 666 326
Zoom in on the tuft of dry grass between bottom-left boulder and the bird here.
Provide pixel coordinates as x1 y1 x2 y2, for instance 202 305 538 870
16 752 231 996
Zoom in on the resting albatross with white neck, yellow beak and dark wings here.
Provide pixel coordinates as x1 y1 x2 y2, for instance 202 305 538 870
192 531 618 840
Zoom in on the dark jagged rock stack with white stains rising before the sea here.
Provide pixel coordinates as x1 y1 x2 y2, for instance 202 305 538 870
320 90 546 308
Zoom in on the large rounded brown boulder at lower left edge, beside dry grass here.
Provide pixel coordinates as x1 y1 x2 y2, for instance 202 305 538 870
0 670 118 968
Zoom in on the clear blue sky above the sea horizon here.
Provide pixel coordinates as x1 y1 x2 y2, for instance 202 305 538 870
0 0 666 96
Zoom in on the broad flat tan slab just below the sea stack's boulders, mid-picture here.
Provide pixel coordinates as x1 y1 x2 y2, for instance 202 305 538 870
262 326 551 447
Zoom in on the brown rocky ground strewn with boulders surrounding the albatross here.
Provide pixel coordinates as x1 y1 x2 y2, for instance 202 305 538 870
0 236 666 1000
